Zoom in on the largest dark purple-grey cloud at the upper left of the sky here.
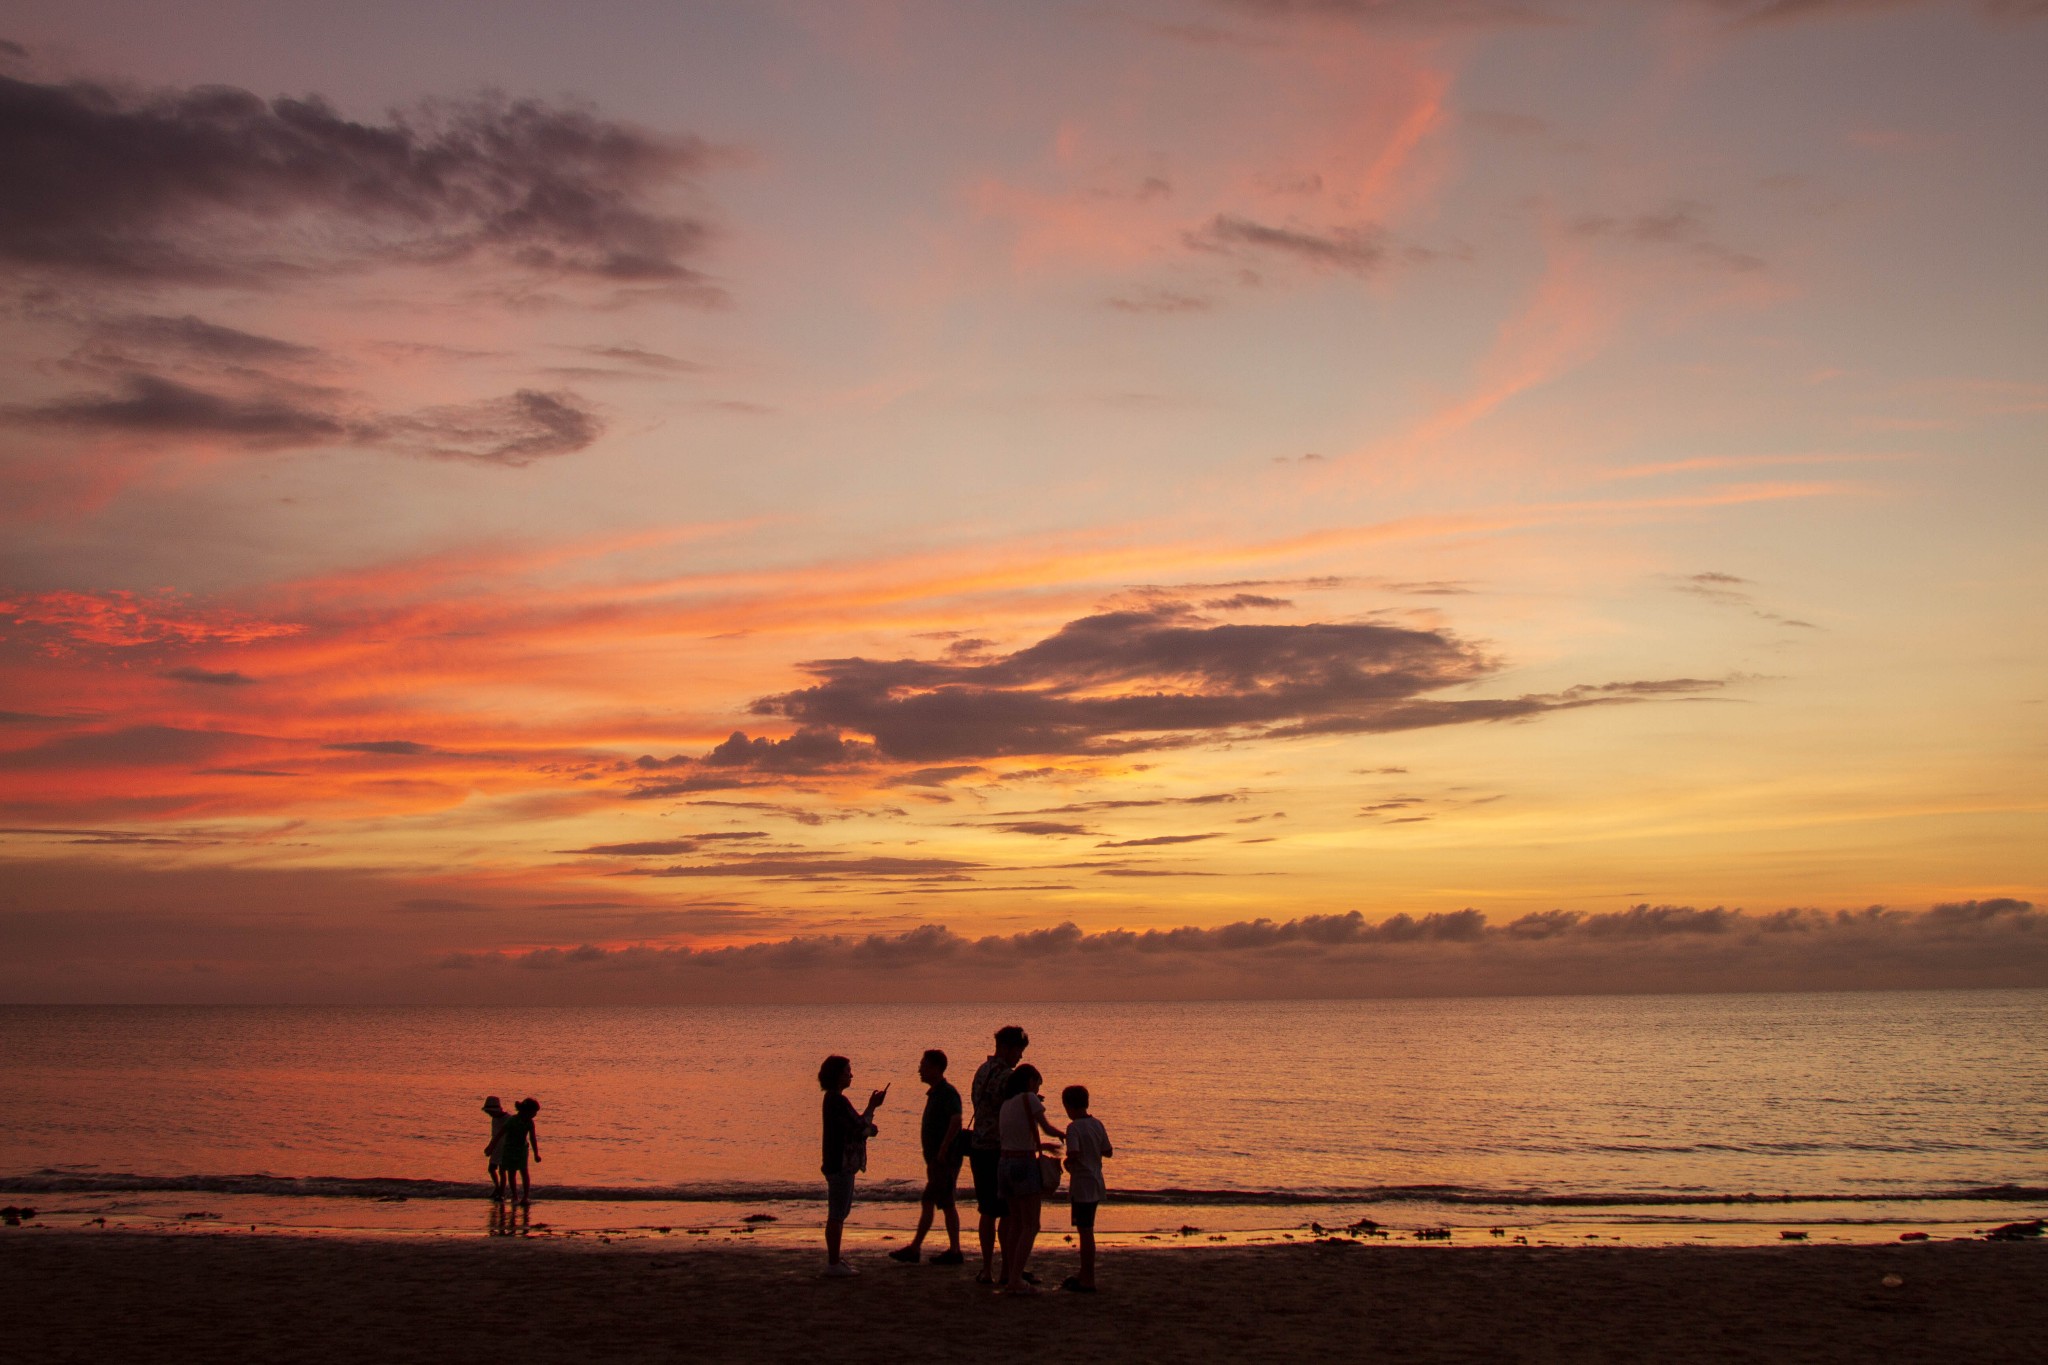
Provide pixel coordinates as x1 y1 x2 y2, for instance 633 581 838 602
0 78 711 291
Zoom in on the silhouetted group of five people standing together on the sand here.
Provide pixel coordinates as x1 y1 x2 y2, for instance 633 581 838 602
817 1025 1112 1293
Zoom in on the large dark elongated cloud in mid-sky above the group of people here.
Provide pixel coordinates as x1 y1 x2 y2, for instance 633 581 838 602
754 604 1702 763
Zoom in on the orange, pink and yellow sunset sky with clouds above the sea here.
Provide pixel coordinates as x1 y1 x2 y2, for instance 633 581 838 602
0 0 2048 1001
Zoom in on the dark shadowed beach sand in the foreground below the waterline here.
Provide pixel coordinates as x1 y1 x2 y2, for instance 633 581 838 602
0 1228 2048 1365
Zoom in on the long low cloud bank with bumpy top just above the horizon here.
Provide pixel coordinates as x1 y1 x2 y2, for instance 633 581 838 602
444 896 2048 999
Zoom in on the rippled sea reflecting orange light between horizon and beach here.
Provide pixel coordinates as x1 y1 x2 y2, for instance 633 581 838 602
0 990 2048 1252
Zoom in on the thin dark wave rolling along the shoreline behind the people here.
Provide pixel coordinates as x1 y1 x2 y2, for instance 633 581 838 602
0 1171 2048 1207
